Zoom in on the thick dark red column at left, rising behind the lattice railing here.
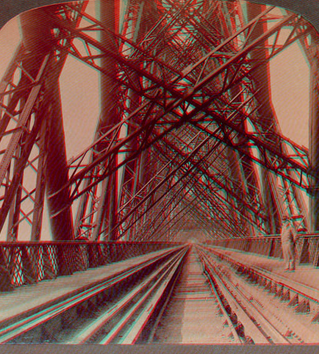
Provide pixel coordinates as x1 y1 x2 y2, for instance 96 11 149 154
20 9 74 240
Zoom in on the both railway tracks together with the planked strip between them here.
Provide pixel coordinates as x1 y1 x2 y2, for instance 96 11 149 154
0 245 319 345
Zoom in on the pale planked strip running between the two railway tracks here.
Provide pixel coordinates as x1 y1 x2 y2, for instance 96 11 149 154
152 247 243 344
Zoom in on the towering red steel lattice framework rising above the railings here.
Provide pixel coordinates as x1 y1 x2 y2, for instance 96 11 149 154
0 0 319 241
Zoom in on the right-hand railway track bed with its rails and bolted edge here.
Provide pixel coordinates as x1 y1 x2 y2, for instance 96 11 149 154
198 246 319 344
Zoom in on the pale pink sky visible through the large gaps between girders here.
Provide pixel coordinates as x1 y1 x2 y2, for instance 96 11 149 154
0 0 309 240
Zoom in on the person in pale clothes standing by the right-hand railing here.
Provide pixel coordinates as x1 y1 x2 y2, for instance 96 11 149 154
281 216 297 271
